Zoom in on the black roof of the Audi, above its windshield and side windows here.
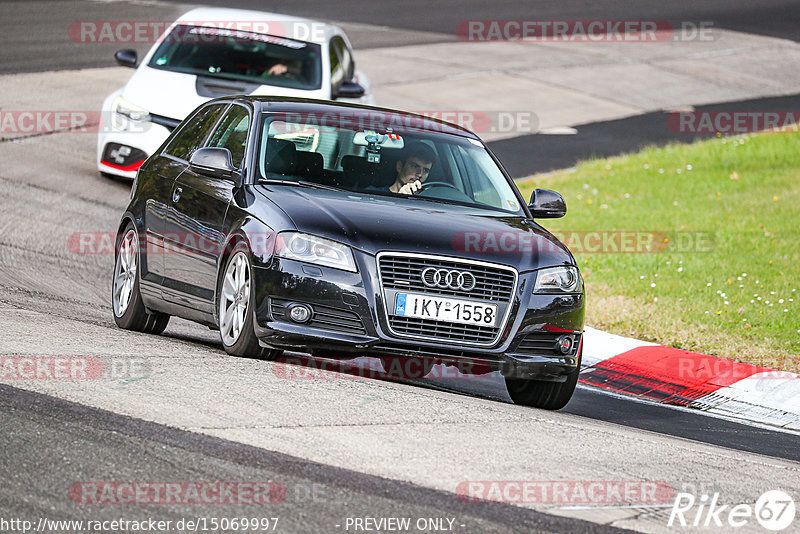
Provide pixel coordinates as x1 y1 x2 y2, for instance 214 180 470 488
222 95 480 141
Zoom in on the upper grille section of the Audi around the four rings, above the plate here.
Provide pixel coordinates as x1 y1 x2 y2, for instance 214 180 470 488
378 255 516 302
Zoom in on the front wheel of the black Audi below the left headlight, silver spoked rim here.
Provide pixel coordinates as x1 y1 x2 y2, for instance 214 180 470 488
217 241 283 360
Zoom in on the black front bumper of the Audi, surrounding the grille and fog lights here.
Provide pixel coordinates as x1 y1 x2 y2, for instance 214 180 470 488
254 253 585 381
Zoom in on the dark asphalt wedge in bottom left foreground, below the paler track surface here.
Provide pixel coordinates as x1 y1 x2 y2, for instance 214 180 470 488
0 385 626 534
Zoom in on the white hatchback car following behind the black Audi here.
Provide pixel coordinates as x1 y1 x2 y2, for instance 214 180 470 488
97 8 374 179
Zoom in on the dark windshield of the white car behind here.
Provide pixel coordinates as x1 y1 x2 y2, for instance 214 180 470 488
148 25 322 90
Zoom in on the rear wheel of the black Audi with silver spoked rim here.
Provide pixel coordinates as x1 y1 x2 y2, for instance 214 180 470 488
111 223 169 334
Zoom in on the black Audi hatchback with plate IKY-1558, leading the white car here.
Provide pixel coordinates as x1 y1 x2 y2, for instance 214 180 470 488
112 97 584 409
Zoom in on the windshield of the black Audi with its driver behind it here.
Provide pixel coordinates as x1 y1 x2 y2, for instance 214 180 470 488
258 111 522 214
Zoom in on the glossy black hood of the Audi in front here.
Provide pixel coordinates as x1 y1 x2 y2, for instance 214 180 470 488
257 185 575 272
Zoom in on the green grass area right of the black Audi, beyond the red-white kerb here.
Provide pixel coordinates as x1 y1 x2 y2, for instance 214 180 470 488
517 133 800 371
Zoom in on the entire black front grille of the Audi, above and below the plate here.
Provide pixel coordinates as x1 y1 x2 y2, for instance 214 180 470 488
378 254 517 345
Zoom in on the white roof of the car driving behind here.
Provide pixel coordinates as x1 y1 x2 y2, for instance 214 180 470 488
175 7 343 44
